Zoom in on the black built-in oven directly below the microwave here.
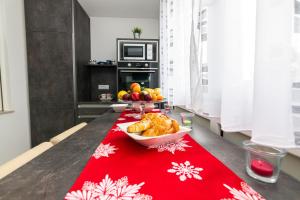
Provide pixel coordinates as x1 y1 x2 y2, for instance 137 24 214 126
118 68 158 91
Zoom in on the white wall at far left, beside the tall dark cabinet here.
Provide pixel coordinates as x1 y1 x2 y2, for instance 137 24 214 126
0 0 30 164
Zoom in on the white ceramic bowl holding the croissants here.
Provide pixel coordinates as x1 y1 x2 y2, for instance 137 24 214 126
117 122 191 147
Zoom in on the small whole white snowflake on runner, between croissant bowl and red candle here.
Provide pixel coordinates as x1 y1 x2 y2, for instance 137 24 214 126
168 161 203 181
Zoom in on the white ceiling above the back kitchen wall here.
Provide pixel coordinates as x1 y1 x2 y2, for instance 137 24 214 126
78 0 159 19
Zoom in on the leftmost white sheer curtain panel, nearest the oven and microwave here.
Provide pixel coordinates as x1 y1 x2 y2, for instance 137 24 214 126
160 0 200 106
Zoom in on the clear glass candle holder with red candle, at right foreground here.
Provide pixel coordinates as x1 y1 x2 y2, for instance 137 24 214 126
243 140 286 183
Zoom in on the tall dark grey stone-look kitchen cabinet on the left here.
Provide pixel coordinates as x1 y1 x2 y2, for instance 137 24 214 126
24 0 90 146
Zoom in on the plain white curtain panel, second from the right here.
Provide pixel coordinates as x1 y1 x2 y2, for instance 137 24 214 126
220 0 256 132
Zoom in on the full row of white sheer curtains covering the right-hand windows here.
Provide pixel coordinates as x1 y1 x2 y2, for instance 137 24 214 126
161 0 300 148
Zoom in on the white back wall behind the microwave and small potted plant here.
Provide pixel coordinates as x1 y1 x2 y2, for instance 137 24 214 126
91 17 159 61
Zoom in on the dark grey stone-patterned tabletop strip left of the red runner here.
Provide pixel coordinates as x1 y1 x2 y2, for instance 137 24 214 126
0 113 119 200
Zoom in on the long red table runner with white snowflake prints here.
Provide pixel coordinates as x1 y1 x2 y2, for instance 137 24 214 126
65 111 264 200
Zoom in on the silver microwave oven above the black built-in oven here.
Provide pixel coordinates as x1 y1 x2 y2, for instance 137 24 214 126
117 39 159 63
